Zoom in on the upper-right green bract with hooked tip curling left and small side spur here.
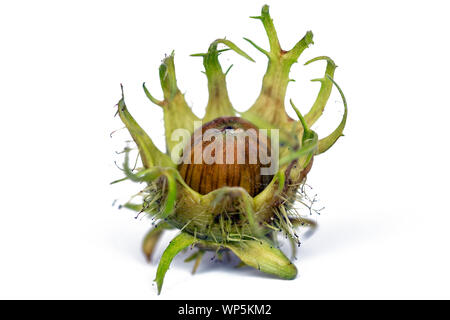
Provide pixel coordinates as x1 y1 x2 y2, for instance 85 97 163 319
305 57 336 126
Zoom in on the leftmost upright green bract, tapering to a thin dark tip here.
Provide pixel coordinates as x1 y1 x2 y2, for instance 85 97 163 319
118 87 174 168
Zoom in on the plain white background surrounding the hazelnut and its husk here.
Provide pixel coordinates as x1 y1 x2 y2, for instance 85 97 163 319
0 0 450 299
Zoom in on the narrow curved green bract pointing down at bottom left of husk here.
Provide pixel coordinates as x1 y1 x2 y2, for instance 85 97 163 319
155 232 196 294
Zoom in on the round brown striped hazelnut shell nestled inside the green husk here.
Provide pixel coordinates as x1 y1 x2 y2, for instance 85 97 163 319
178 117 273 196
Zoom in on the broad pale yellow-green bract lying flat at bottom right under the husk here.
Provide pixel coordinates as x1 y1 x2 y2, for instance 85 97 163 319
224 240 297 280
